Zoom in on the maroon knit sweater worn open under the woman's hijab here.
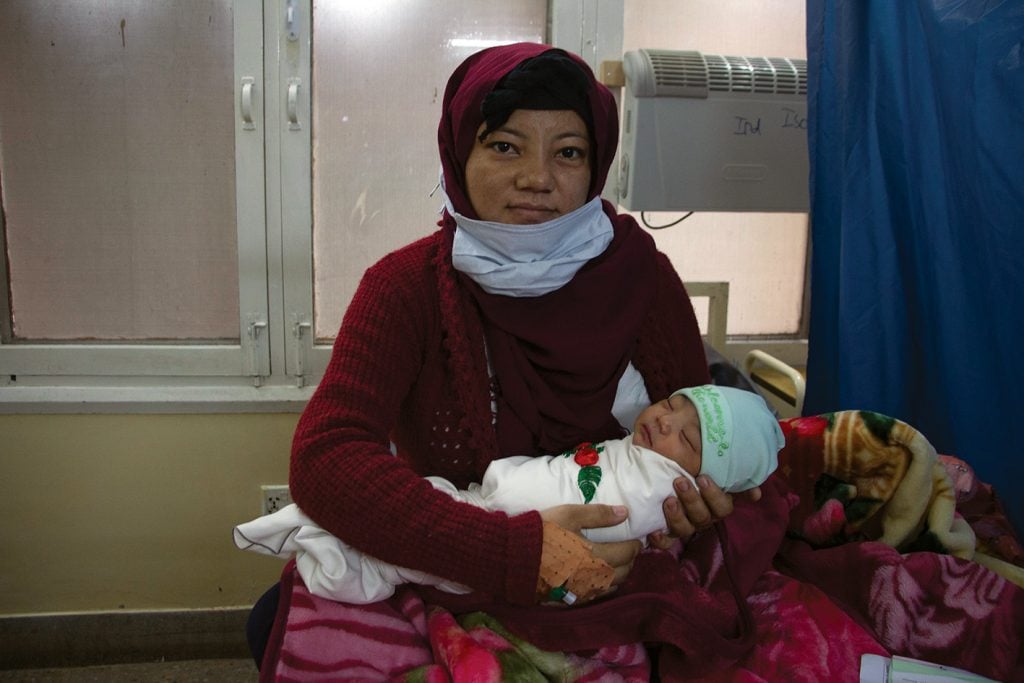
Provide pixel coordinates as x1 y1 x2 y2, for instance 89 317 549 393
290 230 710 604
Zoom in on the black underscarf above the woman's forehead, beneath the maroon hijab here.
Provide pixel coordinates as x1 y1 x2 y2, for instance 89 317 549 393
479 50 594 142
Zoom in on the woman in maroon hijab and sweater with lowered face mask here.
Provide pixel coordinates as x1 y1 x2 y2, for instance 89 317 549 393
254 43 757 679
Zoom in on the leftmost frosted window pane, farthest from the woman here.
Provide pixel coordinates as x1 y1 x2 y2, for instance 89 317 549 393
0 0 239 341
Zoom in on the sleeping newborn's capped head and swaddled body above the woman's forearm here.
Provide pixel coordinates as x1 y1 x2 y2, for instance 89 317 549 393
471 385 785 543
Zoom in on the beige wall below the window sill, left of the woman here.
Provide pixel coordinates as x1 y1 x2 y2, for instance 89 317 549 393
0 415 298 615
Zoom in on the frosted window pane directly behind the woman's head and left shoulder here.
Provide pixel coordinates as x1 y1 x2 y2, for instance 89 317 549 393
312 0 547 339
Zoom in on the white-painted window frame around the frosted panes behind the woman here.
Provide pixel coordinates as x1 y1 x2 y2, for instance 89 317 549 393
0 0 806 414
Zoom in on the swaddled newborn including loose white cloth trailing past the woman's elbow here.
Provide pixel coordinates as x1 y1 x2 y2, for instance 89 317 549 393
234 384 785 603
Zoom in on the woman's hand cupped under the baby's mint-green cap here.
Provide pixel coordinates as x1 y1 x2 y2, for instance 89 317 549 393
647 474 761 550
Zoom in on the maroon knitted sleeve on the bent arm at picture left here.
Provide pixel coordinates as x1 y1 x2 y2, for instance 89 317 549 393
290 240 543 604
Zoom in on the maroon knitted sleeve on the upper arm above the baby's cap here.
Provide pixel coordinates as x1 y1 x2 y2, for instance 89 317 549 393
633 252 711 401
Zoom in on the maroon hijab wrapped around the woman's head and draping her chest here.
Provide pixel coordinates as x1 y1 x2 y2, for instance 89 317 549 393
437 43 656 455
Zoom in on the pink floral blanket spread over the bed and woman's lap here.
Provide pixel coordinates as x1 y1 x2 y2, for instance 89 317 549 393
260 414 1024 683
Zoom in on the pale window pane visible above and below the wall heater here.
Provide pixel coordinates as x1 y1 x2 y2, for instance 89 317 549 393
623 0 807 335
